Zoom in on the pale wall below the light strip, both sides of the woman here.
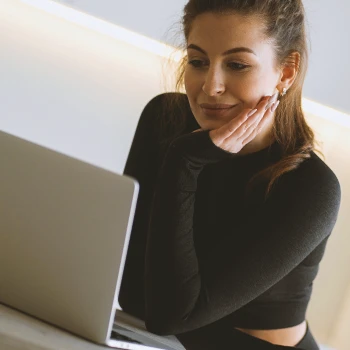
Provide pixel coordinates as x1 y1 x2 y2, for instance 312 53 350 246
0 0 350 350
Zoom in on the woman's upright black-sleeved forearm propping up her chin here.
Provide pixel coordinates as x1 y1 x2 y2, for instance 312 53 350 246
145 146 202 330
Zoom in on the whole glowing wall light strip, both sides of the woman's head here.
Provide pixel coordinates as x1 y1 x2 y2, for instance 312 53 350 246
20 0 350 128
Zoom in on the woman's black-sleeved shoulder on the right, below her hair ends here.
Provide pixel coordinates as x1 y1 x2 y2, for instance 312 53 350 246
259 152 341 238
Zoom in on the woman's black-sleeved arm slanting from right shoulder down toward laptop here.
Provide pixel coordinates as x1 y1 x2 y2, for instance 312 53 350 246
146 154 341 335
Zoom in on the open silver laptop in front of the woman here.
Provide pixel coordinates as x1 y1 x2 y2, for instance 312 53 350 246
0 131 184 350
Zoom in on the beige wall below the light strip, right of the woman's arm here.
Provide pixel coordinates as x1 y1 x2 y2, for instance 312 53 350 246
307 115 350 350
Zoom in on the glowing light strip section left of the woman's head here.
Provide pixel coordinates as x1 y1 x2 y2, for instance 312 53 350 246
20 0 184 62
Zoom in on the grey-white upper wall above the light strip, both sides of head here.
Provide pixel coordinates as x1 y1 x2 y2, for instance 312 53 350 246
50 0 350 114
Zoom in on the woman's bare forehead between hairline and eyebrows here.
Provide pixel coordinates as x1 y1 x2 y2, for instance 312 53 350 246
187 13 269 51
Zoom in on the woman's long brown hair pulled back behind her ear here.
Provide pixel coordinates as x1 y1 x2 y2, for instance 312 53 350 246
159 0 324 199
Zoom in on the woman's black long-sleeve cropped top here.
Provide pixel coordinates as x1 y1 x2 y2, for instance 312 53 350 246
119 94 341 339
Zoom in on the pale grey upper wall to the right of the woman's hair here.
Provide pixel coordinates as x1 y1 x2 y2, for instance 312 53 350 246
303 0 350 115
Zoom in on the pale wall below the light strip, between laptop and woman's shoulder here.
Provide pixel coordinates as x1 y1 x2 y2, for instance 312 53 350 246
0 0 167 172
